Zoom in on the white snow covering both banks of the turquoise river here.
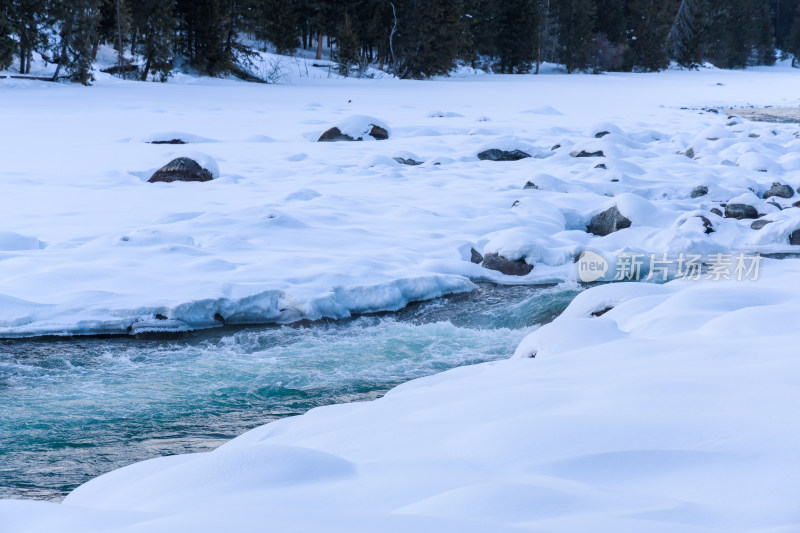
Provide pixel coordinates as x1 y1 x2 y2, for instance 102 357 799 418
0 60 800 533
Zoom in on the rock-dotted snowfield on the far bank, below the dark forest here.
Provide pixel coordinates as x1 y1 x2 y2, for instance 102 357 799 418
0 63 800 337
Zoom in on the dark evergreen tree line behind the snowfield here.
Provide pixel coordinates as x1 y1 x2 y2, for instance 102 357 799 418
0 0 800 84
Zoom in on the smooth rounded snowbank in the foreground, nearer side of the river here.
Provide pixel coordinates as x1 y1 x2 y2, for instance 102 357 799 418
0 261 800 533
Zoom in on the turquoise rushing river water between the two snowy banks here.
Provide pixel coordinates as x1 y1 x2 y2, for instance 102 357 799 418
0 285 577 500
